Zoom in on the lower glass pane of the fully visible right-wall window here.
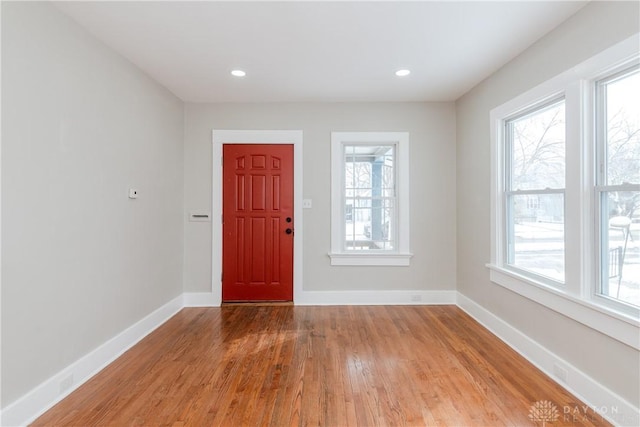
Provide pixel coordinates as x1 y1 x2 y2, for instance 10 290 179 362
508 194 564 282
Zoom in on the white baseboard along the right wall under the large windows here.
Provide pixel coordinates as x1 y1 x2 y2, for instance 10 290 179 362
457 293 640 426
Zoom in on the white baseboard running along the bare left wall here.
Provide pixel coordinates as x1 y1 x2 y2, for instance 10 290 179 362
0 295 183 427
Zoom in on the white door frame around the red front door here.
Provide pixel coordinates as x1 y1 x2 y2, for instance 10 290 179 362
211 129 303 306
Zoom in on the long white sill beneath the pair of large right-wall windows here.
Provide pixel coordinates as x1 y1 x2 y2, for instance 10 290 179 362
487 264 640 350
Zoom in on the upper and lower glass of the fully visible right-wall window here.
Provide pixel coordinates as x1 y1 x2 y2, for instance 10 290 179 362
504 99 566 283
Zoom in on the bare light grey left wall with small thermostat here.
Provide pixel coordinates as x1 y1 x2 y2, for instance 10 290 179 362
1 2 183 407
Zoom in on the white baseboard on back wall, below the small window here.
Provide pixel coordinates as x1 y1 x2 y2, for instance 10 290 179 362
294 291 457 305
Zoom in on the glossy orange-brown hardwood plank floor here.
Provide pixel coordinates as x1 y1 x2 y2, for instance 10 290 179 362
33 305 609 426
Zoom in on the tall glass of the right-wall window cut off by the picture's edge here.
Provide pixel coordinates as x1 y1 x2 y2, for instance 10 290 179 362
595 66 640 306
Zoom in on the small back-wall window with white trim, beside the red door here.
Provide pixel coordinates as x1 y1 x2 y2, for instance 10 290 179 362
329 132 410 265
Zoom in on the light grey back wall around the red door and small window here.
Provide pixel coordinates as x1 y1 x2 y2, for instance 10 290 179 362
184 103 456 298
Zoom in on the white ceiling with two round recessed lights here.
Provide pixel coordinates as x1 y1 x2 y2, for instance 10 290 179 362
56 0 585 102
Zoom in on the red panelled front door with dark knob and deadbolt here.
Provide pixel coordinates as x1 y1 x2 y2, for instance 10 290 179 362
222 144 294 302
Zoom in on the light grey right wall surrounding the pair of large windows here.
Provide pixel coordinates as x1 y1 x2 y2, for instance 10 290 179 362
456 2 640 407
